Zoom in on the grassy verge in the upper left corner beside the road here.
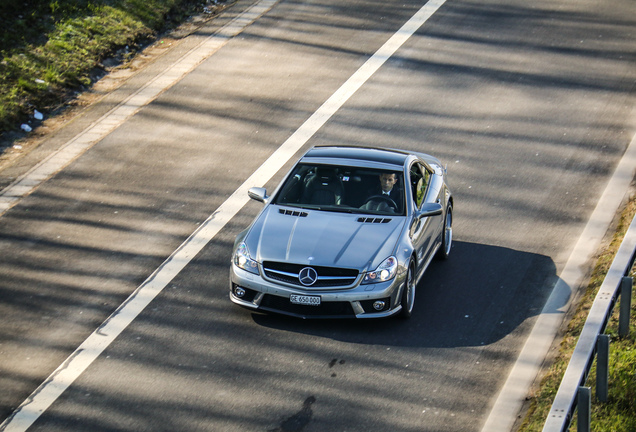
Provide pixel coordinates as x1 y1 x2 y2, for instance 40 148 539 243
0 0 224 135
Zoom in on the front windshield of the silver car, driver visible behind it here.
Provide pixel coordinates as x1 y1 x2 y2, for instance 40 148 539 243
274 164 404 215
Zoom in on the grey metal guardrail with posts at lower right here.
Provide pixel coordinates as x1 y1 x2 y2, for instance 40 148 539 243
543 213 636 432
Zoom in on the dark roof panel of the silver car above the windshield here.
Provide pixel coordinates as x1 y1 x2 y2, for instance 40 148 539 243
302 146 409 167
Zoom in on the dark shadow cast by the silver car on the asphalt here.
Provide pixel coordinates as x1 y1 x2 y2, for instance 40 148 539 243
252 241 570 347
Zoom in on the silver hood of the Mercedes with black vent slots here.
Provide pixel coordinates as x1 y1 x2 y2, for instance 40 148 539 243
245 205 406 271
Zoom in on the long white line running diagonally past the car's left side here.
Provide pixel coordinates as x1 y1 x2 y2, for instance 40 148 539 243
0 0 445 432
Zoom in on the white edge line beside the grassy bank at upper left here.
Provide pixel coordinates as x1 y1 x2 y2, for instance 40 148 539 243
0 0 278 216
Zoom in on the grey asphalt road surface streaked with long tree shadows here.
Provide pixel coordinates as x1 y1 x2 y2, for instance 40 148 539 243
0 0 636 432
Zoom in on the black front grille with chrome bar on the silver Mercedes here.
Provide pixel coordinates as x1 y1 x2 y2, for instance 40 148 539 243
263 261 358 288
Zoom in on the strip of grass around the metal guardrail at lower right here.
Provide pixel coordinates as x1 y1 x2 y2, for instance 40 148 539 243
518 197 636 432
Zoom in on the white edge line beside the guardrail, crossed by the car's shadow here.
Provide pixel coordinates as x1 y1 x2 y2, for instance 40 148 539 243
482 132 636 432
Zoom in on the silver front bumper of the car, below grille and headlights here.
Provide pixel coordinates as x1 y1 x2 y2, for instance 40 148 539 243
230 264 405 318
